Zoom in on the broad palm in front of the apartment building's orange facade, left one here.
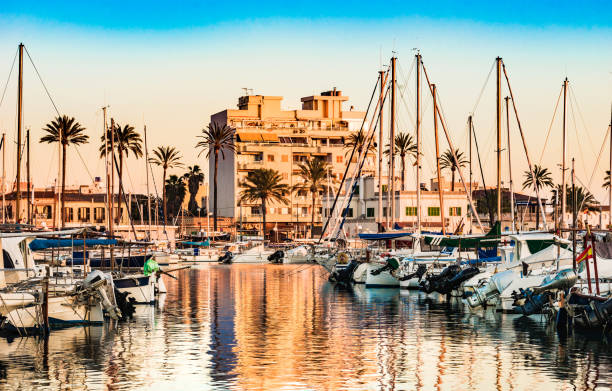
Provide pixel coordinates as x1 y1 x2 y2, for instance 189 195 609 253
240 168 289 240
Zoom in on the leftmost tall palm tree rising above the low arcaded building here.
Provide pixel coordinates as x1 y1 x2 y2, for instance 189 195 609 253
40 115 89 228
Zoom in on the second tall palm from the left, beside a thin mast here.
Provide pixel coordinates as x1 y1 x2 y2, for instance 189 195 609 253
100 124 142 224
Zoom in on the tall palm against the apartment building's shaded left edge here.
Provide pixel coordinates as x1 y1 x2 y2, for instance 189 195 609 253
196 122 236 231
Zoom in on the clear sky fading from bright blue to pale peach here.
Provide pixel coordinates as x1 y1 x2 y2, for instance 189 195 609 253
0 0 612 203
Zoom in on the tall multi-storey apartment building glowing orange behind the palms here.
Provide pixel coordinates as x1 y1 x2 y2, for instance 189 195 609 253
209 89 368 237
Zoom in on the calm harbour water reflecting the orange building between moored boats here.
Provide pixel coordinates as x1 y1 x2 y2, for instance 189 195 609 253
0 265 612 391
